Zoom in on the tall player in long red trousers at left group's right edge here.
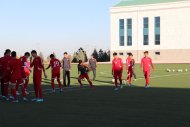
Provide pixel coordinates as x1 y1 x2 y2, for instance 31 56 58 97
30 50 47 102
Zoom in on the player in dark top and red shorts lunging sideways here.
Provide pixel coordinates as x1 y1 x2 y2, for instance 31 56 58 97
78 60 93 88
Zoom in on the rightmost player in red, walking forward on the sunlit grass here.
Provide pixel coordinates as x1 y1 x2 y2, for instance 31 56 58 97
140 51 154 88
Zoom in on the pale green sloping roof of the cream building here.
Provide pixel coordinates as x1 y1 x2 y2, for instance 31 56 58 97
114 0 187 7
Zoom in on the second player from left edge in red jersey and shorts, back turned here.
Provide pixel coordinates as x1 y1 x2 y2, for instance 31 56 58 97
8 51 28 102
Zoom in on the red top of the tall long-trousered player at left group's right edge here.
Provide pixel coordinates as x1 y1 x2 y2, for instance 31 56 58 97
30 56 44 74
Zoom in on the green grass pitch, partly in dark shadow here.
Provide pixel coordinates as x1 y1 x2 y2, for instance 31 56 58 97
0 64 190 127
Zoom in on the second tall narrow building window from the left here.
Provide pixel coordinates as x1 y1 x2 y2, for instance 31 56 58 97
127 19 132 46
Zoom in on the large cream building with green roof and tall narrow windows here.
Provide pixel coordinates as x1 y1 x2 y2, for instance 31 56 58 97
110 0 190 63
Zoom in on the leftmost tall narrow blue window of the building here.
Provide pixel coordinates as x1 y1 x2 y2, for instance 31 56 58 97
119 19 125 46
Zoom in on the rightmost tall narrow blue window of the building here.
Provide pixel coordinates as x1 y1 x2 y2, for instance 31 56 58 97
154 17 160 45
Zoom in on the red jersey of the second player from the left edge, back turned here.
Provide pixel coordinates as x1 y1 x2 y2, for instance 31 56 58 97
8 59 22 79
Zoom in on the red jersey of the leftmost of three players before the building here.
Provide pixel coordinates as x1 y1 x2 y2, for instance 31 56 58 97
112 58 123 71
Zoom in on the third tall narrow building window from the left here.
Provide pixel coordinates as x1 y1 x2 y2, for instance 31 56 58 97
143 17 149 45
